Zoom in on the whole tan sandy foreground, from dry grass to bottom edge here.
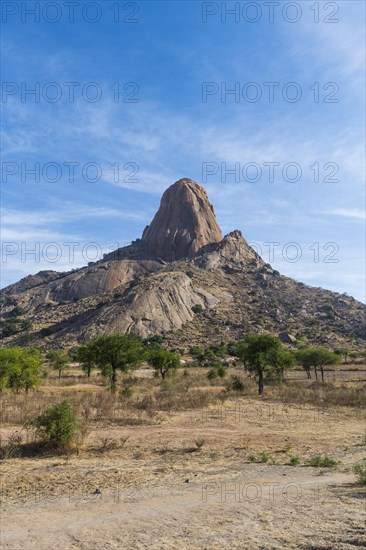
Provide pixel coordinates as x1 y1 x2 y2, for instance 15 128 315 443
1 397 366 550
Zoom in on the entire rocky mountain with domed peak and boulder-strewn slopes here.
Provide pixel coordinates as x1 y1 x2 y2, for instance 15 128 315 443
1 179 366 348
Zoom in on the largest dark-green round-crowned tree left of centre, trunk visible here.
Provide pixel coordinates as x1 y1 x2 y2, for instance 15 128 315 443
87 334 144 391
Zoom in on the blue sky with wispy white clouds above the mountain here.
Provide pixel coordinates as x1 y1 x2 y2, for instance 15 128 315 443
1 0 365 301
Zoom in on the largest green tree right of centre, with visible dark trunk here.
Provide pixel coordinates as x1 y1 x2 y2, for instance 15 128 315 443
236 334 294 395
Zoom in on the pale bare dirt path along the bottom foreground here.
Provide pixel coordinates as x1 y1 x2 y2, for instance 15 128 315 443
1 465 366 550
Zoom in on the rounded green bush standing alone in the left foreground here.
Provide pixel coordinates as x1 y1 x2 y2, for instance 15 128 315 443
32 400 80 450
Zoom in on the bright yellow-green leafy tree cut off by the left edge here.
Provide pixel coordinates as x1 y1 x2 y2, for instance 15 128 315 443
0 347 43 393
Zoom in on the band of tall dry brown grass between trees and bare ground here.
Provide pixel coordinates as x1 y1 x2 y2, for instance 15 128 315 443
0 368 366 434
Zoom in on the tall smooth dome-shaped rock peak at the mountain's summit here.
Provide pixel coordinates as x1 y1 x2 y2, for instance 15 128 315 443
142 179 222 262
